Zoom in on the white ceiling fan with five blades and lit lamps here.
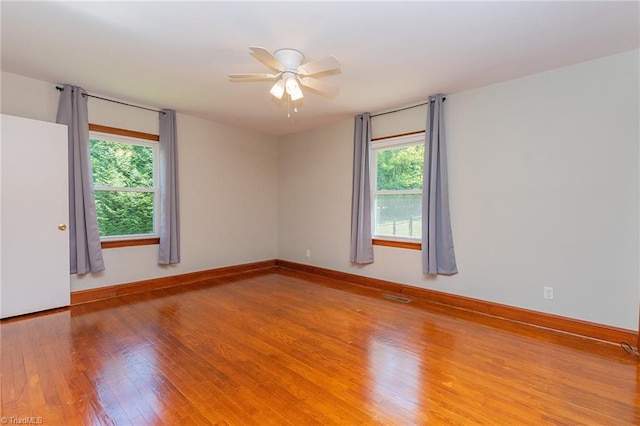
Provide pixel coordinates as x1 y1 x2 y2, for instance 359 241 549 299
229 46 340 101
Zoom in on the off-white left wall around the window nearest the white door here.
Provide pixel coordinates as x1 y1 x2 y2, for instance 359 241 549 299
1 73 277 290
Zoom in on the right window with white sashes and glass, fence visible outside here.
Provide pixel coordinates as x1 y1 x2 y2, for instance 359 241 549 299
371 132 424 241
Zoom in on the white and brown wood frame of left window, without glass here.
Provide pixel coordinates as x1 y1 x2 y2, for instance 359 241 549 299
89 123 160 249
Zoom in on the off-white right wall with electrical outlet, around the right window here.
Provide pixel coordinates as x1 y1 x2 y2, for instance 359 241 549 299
278 51 640 330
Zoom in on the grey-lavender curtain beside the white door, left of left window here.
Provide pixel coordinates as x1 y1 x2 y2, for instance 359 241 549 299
56 84 104 274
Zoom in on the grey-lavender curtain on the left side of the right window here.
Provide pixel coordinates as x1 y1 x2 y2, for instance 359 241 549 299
350 113 373 264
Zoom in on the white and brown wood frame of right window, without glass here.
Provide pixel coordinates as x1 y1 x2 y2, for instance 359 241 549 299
369 130 426 250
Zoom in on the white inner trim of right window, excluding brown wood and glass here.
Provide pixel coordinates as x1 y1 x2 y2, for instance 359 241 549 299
369 133 425 243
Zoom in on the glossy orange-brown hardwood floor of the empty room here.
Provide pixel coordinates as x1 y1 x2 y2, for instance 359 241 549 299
0 270 640 425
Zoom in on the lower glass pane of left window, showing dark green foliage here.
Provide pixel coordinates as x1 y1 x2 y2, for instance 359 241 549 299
95 190 154 237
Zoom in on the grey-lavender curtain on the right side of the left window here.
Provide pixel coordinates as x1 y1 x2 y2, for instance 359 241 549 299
158 109 180 265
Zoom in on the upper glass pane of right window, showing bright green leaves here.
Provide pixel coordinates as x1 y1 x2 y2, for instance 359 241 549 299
376 145 424 191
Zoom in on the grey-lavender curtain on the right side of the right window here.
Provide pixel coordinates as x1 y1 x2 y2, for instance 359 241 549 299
422 95 458 275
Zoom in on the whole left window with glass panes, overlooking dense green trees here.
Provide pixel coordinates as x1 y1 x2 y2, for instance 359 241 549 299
89 125 159 243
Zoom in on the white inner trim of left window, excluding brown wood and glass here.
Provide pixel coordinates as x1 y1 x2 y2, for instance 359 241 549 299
89 131 160 241
